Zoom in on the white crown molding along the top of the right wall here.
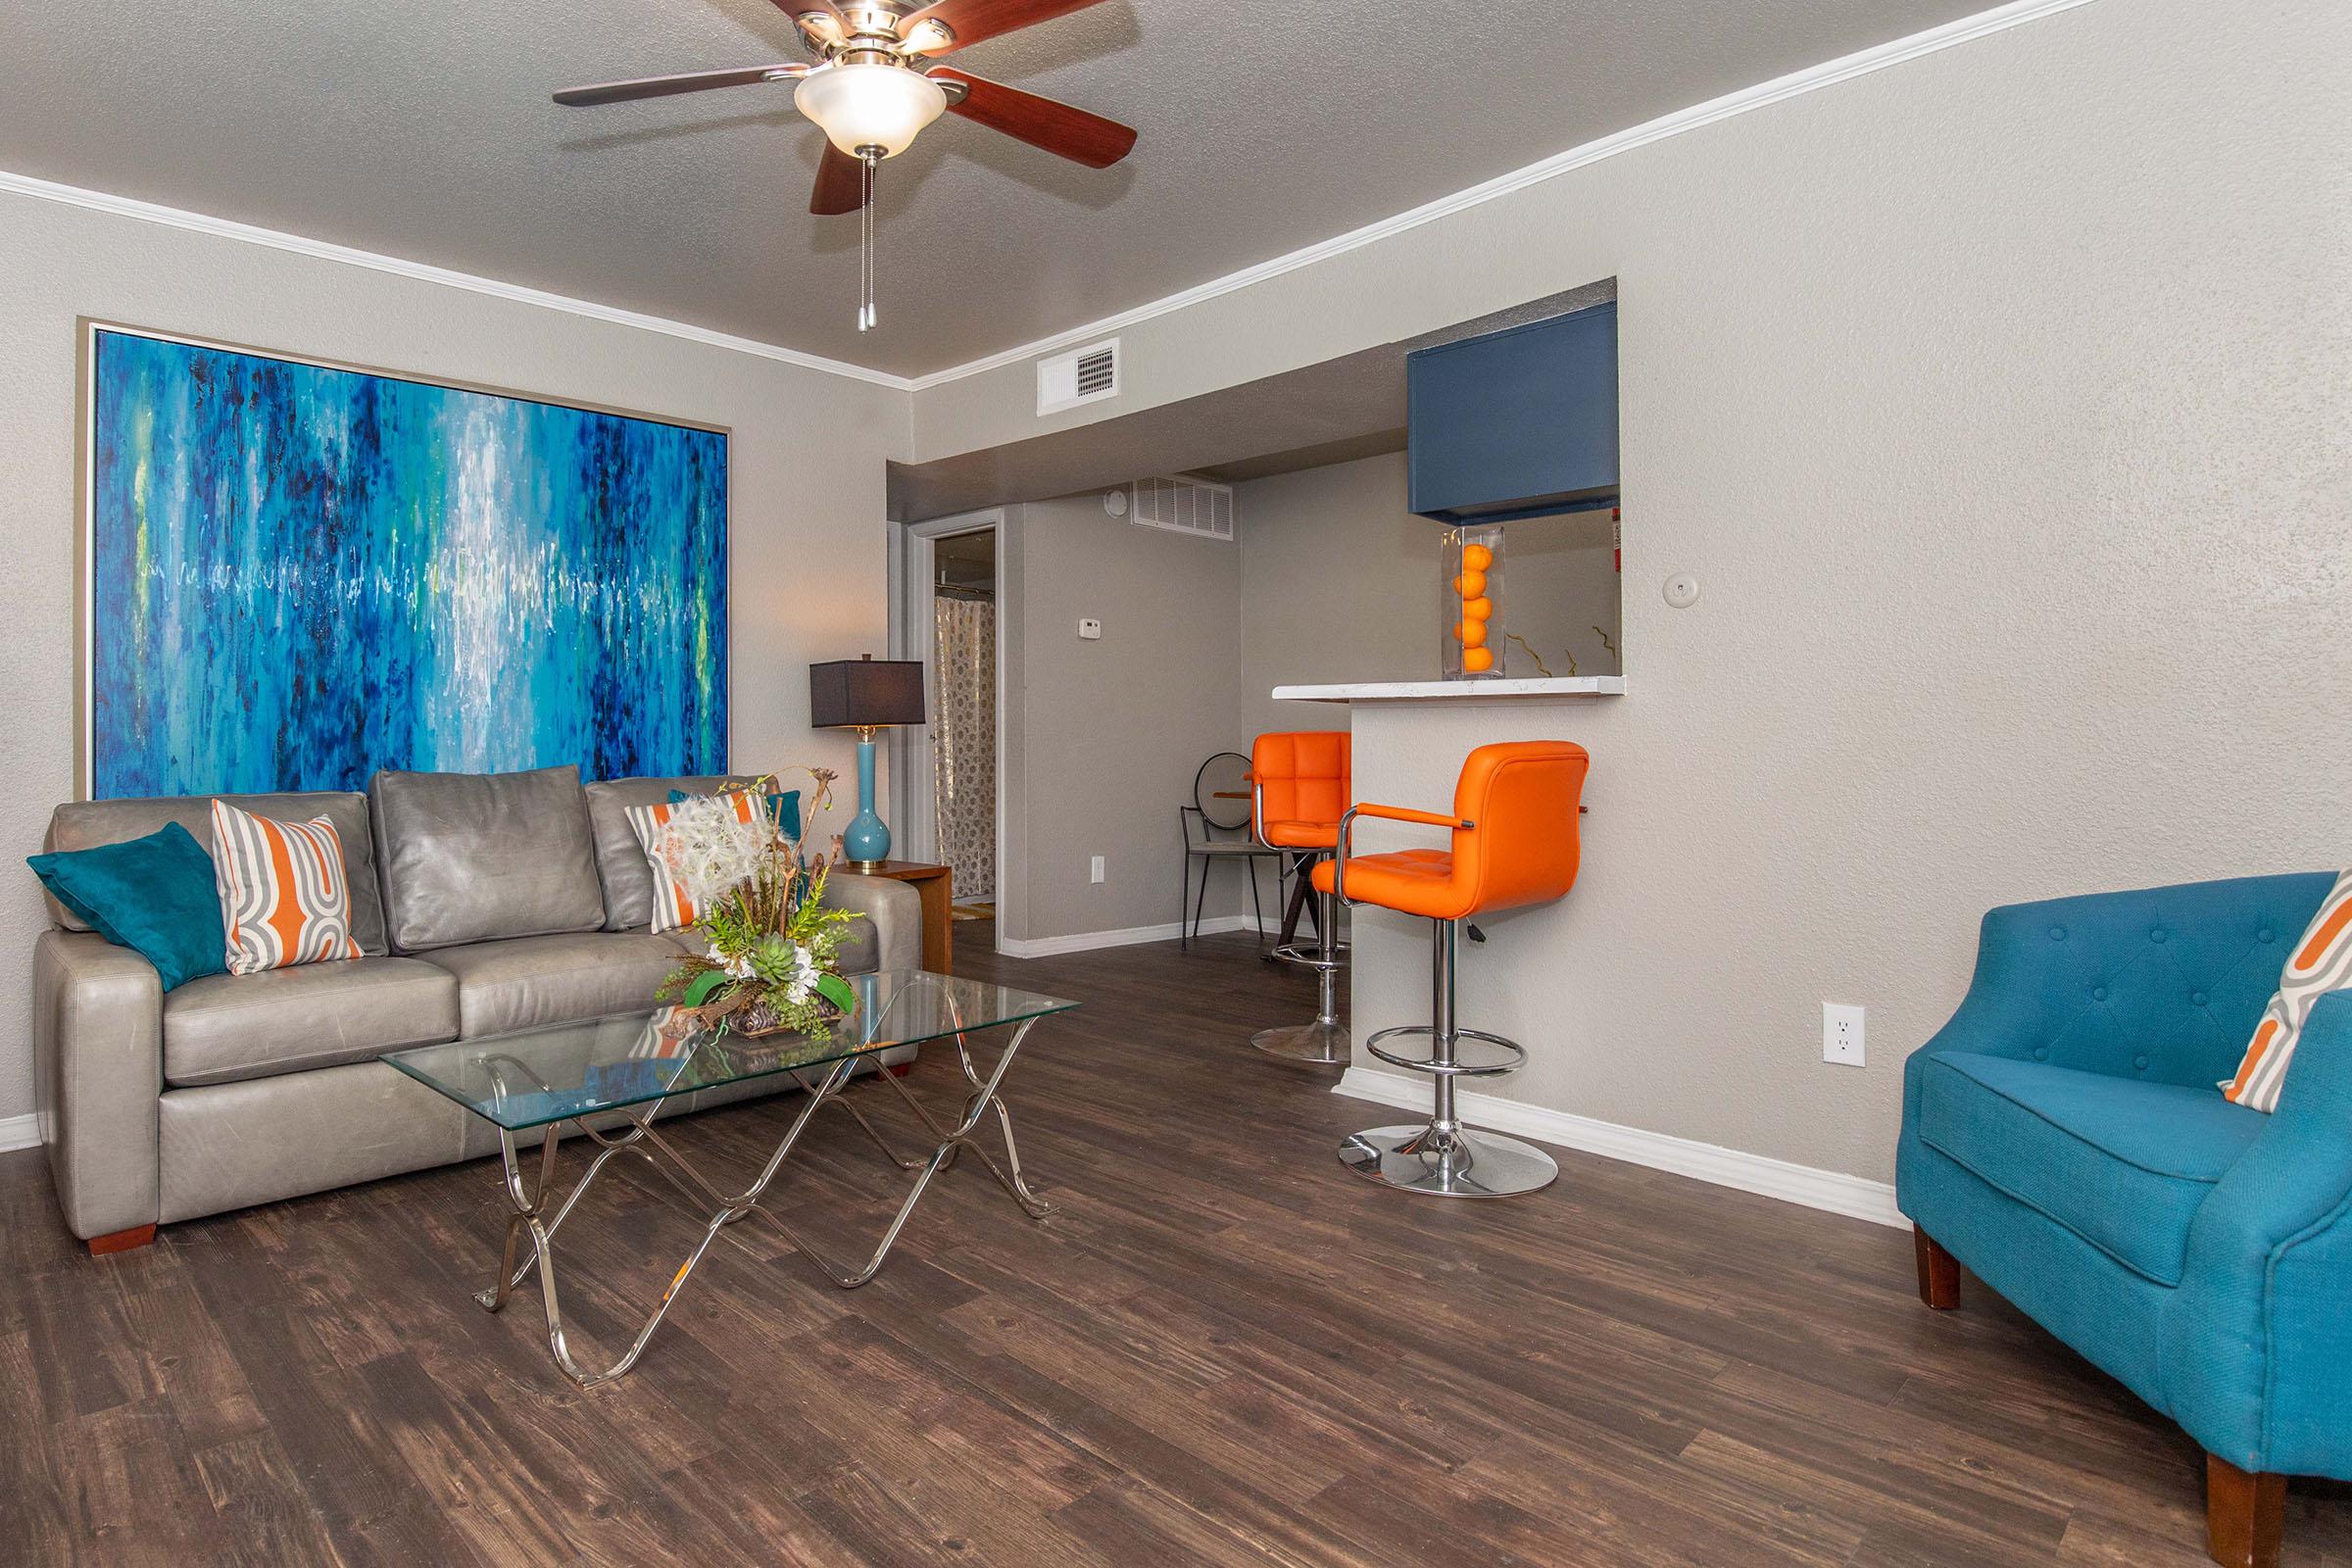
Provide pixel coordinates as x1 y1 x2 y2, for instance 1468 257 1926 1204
910 0 2091 393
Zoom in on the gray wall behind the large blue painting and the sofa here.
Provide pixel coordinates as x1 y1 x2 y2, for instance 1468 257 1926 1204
0 193 906 1116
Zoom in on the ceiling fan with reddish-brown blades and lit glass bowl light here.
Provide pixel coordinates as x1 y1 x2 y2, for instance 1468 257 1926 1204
555 0 1136 331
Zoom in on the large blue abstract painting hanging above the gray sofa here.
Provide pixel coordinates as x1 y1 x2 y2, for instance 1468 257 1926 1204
87 326 727 800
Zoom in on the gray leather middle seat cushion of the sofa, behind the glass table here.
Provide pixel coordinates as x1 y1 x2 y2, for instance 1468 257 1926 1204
430 931 687 1039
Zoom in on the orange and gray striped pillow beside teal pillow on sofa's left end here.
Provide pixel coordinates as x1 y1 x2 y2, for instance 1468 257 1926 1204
212 802 360 976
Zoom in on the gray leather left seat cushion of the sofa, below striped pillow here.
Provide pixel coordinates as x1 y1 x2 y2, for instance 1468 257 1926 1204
163 959 459 1084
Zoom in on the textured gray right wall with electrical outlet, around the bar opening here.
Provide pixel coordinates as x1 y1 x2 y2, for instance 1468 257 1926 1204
917 0 2352 1178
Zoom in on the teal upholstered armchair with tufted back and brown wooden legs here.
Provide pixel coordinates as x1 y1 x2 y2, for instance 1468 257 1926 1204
1895 872 2352 1563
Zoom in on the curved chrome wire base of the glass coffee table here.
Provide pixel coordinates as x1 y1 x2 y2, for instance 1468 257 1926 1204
475 1020 1052 1390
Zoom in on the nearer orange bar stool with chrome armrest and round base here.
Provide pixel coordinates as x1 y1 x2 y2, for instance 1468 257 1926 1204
1315 741 1592 1199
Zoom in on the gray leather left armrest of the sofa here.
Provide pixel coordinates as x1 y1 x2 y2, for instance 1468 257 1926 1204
33 931 163 1242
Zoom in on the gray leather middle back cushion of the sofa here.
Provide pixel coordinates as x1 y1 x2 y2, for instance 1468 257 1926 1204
367 766 605 953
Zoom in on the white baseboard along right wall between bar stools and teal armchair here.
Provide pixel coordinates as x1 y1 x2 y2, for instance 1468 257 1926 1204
1331 1067 1910 1225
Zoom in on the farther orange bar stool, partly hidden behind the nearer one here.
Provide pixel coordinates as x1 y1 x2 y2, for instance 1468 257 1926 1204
1249 729 1354 1067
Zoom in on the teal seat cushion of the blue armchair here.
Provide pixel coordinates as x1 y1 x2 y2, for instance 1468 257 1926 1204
1919 1051 2268 1286
